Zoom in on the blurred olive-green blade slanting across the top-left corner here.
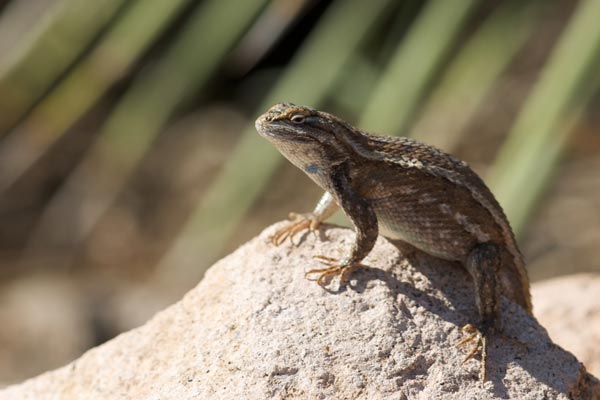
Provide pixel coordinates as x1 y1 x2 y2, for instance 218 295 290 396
0 0 125 133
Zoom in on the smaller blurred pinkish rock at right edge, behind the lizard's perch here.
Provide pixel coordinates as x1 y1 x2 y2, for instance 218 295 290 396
532 274 600 376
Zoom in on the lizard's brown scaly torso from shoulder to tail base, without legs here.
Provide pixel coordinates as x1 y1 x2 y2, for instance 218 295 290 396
346 132 532 312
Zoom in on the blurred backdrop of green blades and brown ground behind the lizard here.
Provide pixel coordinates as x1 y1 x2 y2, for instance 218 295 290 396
0 0 600 383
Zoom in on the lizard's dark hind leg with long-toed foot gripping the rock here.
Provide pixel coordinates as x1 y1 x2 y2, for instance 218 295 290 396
457 243 503 381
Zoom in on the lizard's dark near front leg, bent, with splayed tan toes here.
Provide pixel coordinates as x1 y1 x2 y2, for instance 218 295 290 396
306 169 378 285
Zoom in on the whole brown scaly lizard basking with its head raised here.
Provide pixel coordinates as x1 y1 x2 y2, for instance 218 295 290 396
255 103 532 381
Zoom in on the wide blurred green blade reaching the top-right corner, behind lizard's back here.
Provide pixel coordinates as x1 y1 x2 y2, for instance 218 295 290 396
490 1 600 232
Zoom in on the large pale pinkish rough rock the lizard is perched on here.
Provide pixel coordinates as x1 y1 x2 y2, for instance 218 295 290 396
0 223 600 399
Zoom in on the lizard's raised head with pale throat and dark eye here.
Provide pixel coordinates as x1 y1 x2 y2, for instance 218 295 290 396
256 103 348 170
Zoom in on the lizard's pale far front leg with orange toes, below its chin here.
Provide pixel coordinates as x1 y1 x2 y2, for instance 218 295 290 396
271 192 340 246
